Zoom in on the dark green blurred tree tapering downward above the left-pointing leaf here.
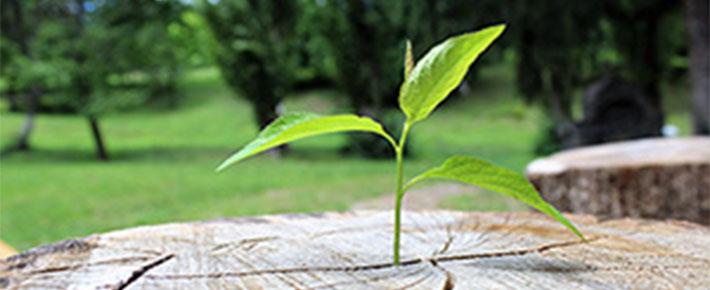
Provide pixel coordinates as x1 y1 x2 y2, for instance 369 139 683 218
201 0 302 156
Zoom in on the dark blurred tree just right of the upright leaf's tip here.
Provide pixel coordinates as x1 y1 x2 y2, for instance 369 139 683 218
510 0 603 124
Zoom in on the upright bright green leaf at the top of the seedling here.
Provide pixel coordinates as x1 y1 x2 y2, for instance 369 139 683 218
399 24 505 123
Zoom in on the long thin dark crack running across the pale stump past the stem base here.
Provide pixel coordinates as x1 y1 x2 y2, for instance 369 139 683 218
144 238 599 280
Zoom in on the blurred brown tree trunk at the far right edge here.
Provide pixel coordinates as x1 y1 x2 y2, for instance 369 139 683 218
685 0 710 135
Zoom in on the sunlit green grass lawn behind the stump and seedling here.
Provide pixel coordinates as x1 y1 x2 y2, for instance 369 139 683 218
0 64 688 250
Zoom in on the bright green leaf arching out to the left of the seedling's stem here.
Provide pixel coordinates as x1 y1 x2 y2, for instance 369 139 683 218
217 113 395 171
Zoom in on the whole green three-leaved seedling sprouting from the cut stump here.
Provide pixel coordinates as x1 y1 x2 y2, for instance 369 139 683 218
217 25 584 265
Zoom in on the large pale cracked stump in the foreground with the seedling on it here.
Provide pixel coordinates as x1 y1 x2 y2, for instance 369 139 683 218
0 211 710 289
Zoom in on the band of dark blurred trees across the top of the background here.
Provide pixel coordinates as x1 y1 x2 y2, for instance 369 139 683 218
0 0 710 158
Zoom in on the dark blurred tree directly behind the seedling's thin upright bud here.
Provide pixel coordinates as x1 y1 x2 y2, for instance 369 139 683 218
322 0 412 158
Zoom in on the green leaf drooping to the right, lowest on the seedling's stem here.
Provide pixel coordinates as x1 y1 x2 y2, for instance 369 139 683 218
405 156 584 240
